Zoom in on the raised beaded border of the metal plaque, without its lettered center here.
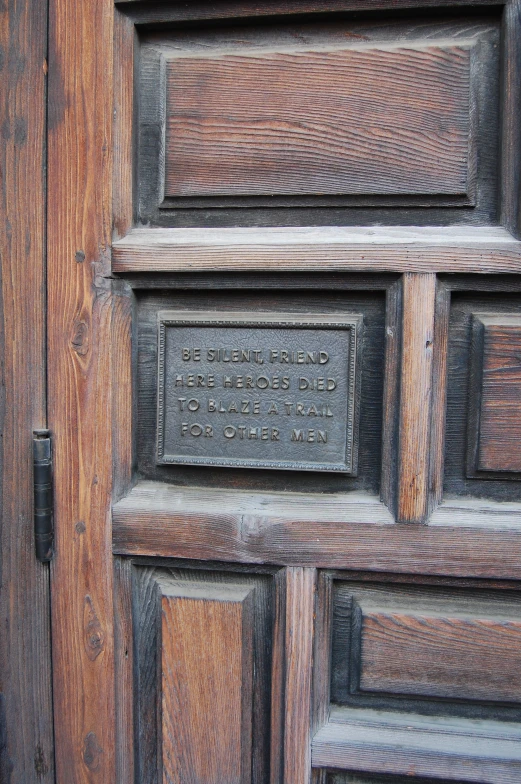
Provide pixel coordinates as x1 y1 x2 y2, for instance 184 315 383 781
157 310 363 476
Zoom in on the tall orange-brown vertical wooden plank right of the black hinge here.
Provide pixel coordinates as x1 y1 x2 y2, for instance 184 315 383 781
47 0 116 784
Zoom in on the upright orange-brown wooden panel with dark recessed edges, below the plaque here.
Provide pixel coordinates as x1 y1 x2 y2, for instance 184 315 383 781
133 561 272 784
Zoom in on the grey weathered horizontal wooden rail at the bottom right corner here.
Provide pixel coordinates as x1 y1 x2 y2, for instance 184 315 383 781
313 708 521 784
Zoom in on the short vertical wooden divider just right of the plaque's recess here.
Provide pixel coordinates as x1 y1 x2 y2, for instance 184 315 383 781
397 273 436 523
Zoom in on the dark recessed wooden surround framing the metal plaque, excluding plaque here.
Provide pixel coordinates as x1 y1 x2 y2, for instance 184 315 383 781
136 282 385 495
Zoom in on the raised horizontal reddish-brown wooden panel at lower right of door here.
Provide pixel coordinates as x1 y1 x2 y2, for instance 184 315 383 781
353 591 521 702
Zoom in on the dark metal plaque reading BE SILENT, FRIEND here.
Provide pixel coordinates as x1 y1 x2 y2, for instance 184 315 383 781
157 311 362 474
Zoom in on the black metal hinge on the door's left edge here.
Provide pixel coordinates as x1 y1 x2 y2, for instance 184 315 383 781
33 430 54 562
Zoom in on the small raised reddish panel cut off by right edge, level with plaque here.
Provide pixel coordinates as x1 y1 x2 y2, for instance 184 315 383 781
468 314 521 476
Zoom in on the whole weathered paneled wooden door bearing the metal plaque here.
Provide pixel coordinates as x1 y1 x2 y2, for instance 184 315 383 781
48 0 521 784
